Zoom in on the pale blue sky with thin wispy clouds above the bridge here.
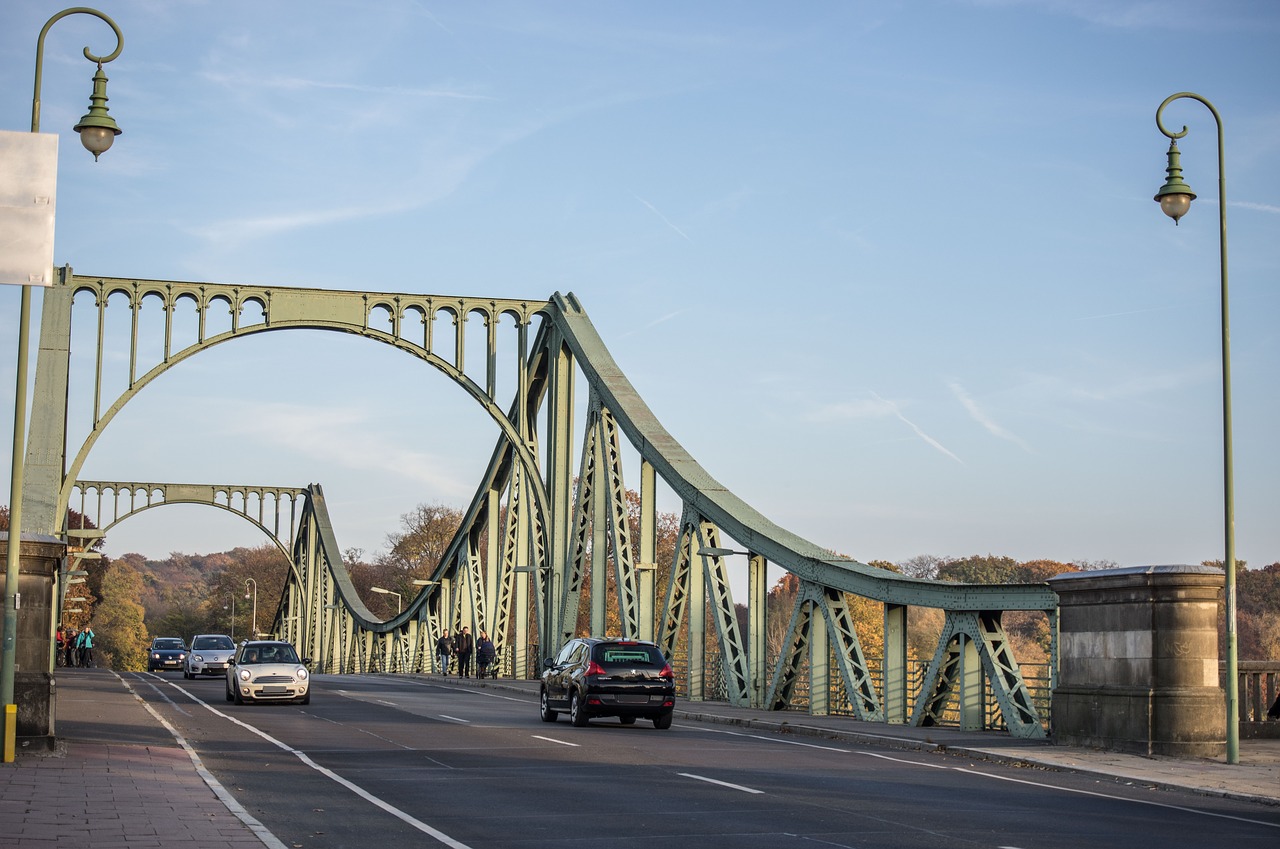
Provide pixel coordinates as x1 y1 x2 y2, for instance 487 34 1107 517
0 0 1280 578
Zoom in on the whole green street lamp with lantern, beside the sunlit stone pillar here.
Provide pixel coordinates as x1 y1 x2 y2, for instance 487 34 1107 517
1155 91 1240 763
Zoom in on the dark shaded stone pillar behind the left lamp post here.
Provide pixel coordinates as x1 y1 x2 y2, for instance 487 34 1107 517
0 531 67 738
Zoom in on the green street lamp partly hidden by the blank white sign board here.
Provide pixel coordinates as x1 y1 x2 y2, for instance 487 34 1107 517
0 6 124 763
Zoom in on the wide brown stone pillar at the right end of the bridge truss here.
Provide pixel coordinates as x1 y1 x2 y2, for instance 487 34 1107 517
1048 566 1226 758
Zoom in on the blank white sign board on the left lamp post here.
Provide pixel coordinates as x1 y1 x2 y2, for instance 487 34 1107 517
0 131 58 286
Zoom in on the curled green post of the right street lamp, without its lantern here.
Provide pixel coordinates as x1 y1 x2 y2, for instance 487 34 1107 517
1156 91 1240 763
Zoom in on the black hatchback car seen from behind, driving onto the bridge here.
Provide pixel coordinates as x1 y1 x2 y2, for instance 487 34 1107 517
539 638 676 729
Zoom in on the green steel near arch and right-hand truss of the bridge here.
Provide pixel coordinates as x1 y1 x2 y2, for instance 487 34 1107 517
23 269 1056 736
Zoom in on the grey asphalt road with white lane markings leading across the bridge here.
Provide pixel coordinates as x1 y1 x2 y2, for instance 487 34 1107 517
125 674 1280 849
